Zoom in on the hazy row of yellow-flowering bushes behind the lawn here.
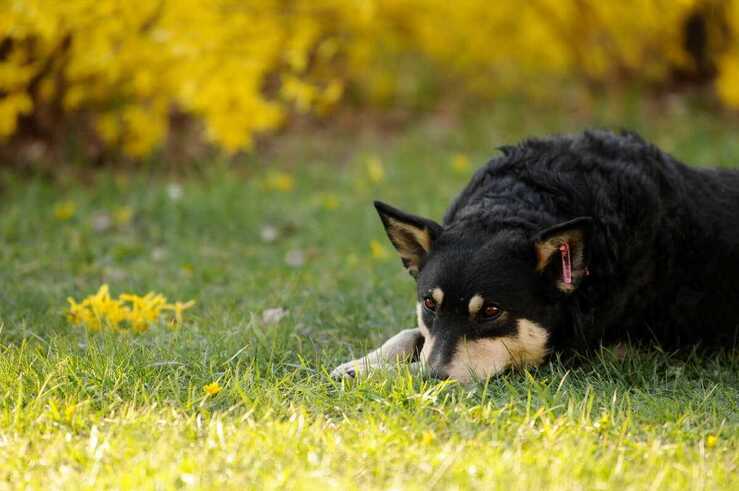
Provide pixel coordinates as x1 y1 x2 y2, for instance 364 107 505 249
0 0 739 156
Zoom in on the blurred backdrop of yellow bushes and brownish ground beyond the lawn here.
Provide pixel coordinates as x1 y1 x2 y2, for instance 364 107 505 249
0 0 739 169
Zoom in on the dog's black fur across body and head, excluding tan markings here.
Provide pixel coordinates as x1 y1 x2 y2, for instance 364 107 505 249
378 131 739 356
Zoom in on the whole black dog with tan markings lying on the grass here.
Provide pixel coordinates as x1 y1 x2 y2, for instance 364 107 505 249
332 130 739 382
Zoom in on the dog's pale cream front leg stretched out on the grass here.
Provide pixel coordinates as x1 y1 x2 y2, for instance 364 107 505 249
331 329 423 378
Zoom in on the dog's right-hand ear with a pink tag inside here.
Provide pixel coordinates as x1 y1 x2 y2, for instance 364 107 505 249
534 217 593 293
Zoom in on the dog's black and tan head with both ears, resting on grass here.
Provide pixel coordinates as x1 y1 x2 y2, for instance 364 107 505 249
375 202 591 381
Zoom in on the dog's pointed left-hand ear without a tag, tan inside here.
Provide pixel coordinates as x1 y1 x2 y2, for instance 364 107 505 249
375 201 442 278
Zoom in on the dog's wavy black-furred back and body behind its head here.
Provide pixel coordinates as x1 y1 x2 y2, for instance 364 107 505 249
444 131 739 346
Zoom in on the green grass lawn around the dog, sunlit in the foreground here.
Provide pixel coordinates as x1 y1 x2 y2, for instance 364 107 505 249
0 98 739 490
